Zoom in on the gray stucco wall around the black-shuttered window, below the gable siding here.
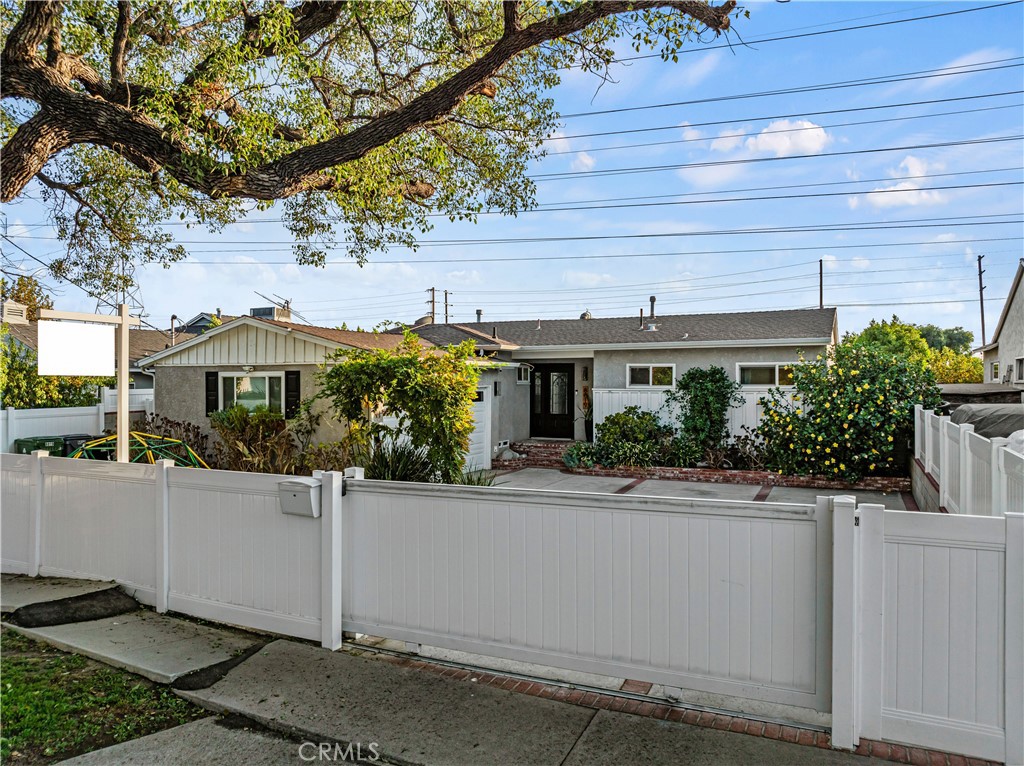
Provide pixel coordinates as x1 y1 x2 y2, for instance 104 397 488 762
154 365 344 441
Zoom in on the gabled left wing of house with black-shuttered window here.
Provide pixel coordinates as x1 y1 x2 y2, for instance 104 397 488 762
141 309 440 441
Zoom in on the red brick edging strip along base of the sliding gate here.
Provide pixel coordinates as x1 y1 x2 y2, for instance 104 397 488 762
368 646 1000 766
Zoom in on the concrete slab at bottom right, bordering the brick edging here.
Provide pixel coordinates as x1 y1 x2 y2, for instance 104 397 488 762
565 711 888 766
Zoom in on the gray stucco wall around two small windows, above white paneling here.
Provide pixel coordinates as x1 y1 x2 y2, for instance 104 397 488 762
593 345 825 388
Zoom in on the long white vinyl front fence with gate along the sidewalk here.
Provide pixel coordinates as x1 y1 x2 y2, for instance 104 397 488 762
0 453 1024 763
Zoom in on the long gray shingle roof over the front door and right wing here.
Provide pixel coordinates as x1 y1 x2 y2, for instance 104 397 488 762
403 308 836 349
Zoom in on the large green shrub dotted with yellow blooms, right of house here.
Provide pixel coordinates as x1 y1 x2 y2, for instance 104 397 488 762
758 342 940 481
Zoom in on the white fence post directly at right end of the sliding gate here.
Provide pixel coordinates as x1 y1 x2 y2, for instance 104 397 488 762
829 497 860 750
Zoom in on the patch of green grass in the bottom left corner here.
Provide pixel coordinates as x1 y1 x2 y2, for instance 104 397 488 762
0 630 210 766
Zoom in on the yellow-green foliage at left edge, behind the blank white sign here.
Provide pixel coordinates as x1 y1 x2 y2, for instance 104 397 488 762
0 325 107 410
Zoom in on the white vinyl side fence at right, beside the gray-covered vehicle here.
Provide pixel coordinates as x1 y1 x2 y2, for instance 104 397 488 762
914 405 1024 516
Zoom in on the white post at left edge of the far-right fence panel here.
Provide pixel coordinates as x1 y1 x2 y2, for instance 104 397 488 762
857 504 886 739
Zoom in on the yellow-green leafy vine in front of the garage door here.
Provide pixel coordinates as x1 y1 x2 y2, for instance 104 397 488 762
317 332 480 483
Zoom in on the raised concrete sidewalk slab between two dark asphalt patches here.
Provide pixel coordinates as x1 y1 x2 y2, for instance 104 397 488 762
14 610 257 683
